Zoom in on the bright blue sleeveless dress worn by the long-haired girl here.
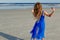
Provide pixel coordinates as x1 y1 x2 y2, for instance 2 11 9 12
30 11 45 39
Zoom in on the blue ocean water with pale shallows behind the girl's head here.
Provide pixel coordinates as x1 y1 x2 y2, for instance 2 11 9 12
0 3 60 9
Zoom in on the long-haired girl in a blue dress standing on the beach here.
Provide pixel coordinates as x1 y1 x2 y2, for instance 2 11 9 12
30 2 55 40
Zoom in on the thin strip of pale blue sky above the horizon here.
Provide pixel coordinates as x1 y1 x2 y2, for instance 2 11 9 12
0 0 60 3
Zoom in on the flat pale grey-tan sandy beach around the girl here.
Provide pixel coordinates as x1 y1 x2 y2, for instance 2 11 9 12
0 8 60 40
